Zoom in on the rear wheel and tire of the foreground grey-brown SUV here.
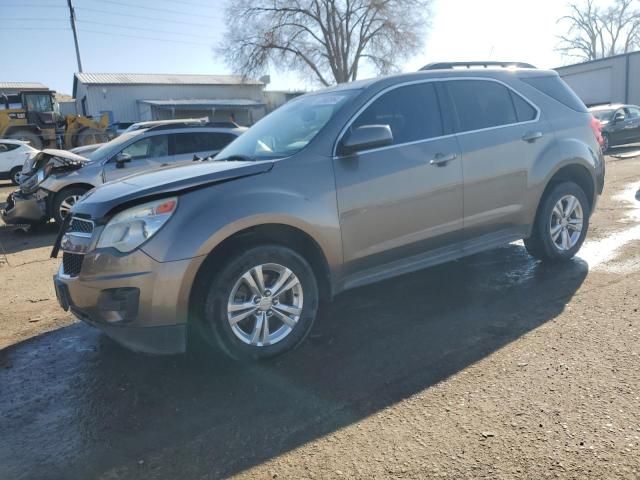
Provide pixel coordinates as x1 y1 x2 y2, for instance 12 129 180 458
524 182 591 261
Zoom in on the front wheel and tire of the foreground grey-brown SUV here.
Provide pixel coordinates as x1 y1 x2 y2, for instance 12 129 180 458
195 245 319 361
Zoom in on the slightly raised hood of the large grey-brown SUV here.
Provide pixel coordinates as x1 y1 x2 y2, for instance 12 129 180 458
73 161 274 221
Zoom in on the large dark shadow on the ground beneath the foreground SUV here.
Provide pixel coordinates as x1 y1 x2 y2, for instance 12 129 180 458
0 244 588 479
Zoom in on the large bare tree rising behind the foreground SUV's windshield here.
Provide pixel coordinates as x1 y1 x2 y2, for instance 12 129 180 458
217 0 431 86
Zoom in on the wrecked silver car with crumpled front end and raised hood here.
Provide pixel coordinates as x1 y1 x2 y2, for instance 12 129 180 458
2 120 247 223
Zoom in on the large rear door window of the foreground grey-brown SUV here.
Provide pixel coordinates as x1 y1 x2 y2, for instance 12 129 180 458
446 80 518 132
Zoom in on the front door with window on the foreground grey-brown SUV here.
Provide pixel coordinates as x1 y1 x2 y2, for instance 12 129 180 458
334 82 463 275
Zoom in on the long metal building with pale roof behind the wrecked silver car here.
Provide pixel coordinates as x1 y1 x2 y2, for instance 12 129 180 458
73 73 265 125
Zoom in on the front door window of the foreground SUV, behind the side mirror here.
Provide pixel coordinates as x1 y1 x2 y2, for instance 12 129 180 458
351 83 442 145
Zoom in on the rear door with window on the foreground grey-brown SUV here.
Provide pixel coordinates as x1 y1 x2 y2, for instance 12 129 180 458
445 79 553 246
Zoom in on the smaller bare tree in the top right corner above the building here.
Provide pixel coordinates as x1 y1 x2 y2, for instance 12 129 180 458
558 0 640 60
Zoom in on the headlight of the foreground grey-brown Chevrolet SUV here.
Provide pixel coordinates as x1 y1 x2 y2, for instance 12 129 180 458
98 197 178 253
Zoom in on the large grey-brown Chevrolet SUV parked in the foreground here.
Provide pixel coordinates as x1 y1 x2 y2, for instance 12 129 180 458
53 65 604 359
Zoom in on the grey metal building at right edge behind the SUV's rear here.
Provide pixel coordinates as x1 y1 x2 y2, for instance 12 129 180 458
556 52 640 106
